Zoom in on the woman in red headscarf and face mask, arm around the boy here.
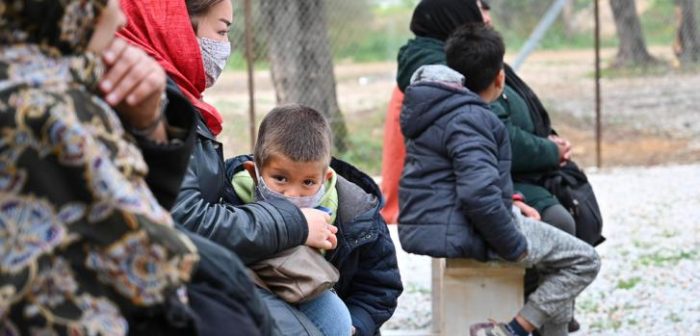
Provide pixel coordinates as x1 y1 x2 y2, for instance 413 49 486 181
119 0 337 334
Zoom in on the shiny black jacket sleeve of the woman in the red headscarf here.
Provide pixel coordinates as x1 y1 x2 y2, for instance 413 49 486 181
172 118 309 264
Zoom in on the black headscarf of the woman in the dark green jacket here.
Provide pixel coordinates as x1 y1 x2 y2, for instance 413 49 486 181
411 0 484 41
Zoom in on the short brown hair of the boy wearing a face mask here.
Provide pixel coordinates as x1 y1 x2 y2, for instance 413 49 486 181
253 104 332 168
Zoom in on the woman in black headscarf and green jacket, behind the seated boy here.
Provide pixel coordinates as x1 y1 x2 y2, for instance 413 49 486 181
382 0 576 234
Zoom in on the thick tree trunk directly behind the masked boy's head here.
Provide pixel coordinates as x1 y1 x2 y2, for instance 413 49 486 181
260 0 347 154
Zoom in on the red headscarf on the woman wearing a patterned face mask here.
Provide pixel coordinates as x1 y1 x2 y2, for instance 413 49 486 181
117 0 223 135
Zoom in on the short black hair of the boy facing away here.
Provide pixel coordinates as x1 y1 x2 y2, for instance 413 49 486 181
445 23 506 93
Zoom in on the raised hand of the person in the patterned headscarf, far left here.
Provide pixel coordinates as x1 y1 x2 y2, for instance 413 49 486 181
99 38 167 142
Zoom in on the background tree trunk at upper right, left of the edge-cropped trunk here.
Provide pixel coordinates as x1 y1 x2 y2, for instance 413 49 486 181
610 0 656 67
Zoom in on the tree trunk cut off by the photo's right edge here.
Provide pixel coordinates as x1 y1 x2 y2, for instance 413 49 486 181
674 0 700 64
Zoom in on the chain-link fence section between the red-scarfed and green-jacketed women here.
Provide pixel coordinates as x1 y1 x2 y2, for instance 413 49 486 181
211 0 414 175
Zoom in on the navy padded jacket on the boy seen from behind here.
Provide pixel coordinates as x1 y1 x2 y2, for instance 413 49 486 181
399 65 527 260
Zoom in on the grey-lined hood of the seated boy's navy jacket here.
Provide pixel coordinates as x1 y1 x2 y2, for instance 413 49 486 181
400 65 488 139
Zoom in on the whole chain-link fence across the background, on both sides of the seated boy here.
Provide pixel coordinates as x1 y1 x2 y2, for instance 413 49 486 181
205 0 700 175
